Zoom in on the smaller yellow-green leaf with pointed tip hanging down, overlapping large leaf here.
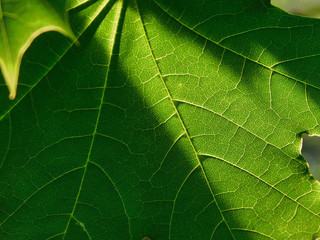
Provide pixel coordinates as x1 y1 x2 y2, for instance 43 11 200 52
0 0 74 99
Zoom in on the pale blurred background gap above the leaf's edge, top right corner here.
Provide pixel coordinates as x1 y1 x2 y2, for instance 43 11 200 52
271 0 320 18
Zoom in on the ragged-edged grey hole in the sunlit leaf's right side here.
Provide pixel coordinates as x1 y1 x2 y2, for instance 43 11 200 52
301 134 320 180
